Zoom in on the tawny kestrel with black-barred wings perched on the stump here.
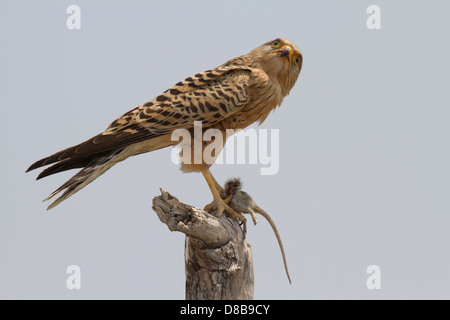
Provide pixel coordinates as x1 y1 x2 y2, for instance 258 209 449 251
27 39 303 221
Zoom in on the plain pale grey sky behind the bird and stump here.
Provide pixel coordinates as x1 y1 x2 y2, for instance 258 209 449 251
0 0 450 299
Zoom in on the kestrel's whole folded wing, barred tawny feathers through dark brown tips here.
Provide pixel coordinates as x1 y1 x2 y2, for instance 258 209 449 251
27 63 251 179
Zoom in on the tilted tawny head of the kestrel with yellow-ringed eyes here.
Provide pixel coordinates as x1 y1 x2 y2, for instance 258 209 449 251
249 39 303 96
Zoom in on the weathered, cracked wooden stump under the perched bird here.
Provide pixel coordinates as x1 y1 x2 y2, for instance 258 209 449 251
153 189 254 300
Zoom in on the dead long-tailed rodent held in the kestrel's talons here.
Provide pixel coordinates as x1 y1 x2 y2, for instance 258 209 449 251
221 178 292 283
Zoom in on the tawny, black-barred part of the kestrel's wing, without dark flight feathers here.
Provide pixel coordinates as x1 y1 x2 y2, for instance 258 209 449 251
107 67 251 135
